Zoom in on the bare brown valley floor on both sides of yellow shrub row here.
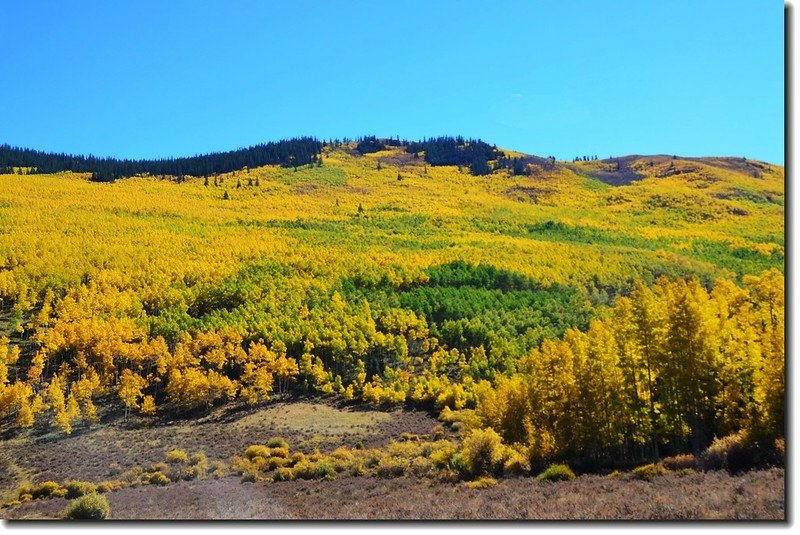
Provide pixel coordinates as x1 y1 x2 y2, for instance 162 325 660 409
0 399 786 520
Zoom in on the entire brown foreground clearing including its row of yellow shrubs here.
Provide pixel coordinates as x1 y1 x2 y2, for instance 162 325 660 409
0 400 785 520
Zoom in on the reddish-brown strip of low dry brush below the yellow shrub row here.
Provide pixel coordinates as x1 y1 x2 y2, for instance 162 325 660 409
3 468 785 520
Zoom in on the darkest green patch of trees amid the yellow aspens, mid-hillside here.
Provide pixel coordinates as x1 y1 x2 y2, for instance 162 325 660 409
342 261 591 372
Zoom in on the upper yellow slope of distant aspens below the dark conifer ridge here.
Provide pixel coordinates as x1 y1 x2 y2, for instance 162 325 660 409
0 150 784 311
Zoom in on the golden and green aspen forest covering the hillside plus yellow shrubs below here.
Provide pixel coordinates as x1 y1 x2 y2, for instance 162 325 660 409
0 140 785 520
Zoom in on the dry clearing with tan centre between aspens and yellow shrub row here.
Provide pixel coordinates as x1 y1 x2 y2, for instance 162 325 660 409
0 401 437 503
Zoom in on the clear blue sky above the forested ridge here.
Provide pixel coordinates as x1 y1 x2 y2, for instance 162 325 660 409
0 0 784 163
